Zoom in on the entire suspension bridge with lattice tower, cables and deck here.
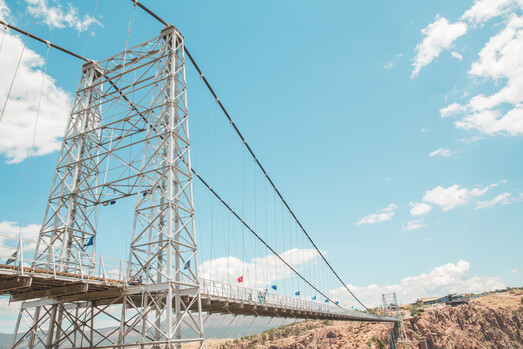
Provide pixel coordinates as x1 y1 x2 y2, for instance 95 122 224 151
0 1 400 348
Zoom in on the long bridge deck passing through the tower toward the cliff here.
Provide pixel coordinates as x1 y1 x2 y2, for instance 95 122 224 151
0 264 398 322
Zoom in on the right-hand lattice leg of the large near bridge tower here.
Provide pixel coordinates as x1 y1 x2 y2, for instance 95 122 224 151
120 26 203 348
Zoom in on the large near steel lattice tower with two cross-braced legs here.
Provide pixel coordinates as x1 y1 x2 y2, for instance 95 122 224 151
12 26 203 348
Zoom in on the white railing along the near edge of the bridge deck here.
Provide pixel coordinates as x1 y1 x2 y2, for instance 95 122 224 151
0 235 392 318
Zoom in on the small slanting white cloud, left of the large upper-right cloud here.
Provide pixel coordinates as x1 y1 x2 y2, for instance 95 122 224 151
411 15 467 77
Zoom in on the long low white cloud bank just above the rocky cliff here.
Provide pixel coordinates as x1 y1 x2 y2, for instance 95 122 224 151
330 260 505 307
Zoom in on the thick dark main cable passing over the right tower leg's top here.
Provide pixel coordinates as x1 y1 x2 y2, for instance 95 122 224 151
131 0 369 310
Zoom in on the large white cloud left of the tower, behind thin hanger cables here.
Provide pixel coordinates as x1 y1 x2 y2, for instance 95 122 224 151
0 22 70 163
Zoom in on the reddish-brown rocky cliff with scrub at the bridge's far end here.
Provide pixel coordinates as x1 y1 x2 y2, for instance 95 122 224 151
207 290 523 349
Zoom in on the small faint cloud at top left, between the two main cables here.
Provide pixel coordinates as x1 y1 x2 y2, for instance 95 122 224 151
26 0 101 32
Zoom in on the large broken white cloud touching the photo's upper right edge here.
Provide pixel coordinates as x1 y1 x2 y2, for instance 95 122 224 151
433 0 523 136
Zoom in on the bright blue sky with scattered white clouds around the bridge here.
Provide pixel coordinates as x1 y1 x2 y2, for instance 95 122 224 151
0 0 523 325
